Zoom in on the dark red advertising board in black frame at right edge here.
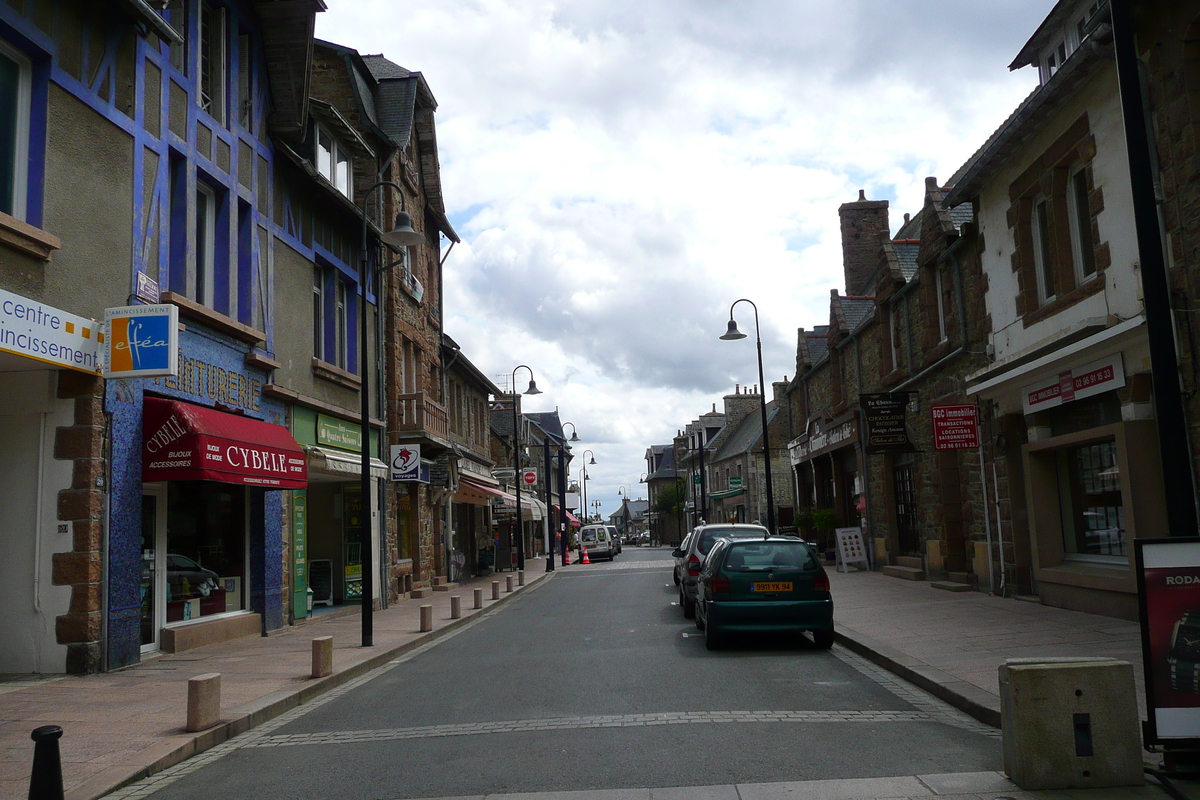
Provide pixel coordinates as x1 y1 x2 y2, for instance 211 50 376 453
1134 536 1200 745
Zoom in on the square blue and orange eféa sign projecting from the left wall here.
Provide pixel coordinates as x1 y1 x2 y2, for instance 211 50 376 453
104 305 179 378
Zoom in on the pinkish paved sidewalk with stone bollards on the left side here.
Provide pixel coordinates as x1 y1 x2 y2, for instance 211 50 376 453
0 558 554 800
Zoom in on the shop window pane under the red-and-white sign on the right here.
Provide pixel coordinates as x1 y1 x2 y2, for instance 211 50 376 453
1055 440 1129 561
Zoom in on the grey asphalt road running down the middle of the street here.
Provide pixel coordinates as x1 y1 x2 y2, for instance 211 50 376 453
136 547 1002 800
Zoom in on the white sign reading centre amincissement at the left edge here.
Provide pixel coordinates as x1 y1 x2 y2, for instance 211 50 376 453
0 289 104 374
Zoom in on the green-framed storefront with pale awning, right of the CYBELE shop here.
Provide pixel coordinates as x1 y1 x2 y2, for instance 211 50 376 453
290 405 388 619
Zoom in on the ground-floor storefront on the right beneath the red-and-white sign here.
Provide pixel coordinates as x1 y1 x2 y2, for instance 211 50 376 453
968 320 1166 619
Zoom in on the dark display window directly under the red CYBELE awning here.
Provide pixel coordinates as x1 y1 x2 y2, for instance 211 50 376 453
167 481 247 622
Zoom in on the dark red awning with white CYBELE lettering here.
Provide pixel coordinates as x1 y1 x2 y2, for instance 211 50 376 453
142 397 308 489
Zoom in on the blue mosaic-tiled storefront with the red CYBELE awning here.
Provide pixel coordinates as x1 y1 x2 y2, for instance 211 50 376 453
106 325 298 669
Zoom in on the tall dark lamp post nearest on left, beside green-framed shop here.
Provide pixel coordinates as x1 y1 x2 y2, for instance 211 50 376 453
359 181 425 648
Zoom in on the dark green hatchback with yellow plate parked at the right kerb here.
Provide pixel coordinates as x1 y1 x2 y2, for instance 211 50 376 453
696 536 833 650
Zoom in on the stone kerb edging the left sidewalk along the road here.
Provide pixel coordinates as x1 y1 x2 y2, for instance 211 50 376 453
90 571 557 798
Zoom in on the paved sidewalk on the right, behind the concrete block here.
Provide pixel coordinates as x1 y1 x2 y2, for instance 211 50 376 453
828 567 1146 728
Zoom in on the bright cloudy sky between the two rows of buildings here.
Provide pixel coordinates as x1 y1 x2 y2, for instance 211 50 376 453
317 0 1054 513
